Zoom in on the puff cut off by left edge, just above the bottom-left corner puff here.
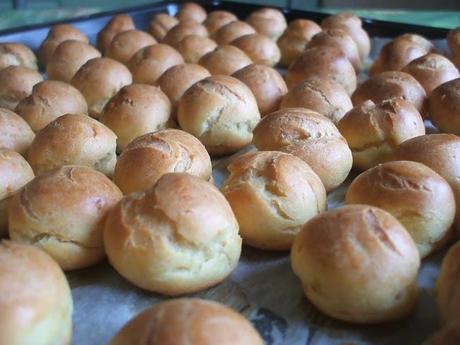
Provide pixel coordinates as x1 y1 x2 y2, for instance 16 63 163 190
0 149 34 238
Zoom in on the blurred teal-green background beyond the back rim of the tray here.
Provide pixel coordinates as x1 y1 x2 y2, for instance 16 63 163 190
0 0 460 30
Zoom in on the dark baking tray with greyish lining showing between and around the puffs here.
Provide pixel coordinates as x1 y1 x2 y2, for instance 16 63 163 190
0 1 448 345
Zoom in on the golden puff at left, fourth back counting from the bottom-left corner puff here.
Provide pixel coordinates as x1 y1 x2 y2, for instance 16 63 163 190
16 79 88 132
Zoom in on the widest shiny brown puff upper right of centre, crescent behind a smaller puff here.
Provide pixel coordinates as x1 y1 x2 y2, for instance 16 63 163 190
286 46 357 95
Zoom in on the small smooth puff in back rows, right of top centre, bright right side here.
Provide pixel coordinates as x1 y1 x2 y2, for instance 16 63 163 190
232 34 281 66
